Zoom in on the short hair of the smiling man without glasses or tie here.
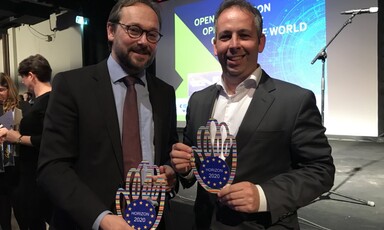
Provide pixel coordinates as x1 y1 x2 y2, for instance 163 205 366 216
215 0 263 38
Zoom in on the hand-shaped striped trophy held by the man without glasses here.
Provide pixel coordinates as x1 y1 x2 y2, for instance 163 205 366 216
192 118 237 193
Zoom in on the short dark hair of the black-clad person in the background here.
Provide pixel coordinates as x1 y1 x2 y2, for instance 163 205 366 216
17 54 52 82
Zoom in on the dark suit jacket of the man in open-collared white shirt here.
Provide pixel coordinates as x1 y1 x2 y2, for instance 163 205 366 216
182 71 335 229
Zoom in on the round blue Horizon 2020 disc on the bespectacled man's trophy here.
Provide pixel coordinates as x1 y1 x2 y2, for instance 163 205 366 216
124 199 157 229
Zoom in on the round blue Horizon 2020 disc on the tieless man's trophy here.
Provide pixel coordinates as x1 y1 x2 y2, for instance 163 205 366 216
199 157 230 189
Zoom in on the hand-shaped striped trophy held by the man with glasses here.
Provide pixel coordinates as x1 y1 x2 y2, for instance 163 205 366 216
116 161 166 229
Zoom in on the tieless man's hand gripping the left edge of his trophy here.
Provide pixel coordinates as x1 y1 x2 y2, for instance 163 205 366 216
170 143 193 174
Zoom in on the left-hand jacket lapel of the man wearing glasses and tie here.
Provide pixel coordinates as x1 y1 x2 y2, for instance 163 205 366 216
93 61 125 180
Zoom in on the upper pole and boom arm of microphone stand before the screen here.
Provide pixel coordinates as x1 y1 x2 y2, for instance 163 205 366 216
311 12 359 125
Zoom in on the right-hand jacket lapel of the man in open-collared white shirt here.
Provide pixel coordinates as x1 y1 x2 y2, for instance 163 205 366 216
236 71 275 144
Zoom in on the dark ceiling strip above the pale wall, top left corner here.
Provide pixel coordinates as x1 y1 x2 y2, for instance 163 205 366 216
0 0 85 31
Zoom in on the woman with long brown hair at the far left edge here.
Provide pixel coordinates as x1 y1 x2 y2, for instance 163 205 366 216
0 73 22 230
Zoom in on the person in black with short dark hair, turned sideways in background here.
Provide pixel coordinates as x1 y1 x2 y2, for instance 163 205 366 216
5 54 52 230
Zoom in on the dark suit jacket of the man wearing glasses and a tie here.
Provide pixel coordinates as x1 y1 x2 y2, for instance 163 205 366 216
38 60 178 229
